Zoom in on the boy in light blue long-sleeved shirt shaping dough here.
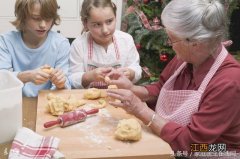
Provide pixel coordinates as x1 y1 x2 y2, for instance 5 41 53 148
0 0 70 97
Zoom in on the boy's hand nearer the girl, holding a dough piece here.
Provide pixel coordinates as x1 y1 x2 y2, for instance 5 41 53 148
50 68 66 89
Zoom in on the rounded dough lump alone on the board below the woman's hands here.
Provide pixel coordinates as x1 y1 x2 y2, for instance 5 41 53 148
115 118 142 141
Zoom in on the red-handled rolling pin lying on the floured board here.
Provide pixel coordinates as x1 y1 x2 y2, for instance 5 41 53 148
43 109 98 128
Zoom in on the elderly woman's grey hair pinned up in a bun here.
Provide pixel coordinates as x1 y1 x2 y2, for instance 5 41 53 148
161 0 226 41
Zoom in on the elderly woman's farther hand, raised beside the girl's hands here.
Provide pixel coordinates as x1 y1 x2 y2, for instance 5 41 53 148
105 70 134 89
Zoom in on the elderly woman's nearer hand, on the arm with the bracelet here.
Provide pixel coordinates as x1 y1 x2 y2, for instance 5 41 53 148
107 89 144 116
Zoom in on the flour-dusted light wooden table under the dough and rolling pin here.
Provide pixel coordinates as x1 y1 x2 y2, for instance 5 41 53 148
0 91 173 159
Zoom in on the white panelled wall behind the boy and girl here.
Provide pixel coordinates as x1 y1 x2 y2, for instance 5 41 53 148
0 0 122 38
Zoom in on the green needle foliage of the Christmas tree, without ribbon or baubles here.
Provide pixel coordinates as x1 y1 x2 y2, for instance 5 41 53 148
122 0 174 82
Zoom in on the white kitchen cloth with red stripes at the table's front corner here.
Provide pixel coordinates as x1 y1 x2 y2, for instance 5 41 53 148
8 127 64 159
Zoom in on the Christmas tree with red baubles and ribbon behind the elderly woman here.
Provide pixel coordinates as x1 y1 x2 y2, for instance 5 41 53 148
121 0 238 82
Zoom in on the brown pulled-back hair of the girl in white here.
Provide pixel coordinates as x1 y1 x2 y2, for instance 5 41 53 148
80 0 117 32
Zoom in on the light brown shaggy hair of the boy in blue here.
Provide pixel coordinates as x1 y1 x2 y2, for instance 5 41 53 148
11 0 60 31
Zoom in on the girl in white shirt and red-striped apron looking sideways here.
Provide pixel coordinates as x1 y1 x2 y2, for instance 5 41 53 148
69 0 142 88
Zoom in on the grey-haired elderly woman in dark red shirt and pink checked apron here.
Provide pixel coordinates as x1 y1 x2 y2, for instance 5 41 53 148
108 0 240 155
